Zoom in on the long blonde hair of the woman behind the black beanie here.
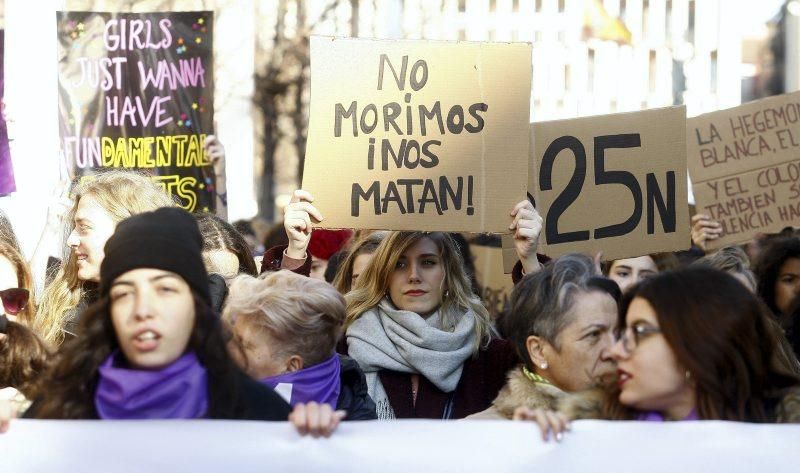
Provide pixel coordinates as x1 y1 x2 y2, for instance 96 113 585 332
34 170 175 346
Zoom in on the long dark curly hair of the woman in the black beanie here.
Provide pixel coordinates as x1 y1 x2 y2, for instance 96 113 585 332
28 290 245 419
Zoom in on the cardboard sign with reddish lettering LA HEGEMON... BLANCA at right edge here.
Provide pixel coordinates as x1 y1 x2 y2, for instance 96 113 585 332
686 92 800 249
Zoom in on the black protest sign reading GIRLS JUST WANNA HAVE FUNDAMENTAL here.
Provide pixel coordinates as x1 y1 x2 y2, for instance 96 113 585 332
57 11 215 211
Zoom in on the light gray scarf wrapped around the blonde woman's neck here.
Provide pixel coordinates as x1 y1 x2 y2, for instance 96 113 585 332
347 298 476 419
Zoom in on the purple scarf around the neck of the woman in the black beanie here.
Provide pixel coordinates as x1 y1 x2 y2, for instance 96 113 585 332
94 351 208 420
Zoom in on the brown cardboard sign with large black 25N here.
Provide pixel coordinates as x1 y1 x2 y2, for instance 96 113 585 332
529 107 690 260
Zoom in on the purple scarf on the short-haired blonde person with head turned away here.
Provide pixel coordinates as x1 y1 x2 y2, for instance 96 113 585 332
261 353 342 409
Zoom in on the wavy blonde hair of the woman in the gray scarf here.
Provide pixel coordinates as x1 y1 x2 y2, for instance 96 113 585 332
345 232 494 354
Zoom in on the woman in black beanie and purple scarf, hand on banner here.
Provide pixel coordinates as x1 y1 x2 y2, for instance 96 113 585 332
18 208 340 435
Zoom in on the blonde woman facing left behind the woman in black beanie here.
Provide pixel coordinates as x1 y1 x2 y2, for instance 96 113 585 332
34 171 175 346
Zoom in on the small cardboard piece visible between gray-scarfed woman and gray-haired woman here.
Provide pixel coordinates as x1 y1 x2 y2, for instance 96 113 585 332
470 245 514 319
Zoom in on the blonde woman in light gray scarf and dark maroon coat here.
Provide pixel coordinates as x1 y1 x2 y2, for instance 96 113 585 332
346 232 517 419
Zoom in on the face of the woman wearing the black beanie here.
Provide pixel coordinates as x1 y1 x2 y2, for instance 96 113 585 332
109 268 195 369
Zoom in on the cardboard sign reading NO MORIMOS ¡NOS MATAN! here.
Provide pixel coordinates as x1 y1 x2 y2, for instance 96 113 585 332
303 37 531 232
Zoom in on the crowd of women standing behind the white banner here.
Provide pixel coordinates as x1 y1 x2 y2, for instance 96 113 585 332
0 142 800 439
